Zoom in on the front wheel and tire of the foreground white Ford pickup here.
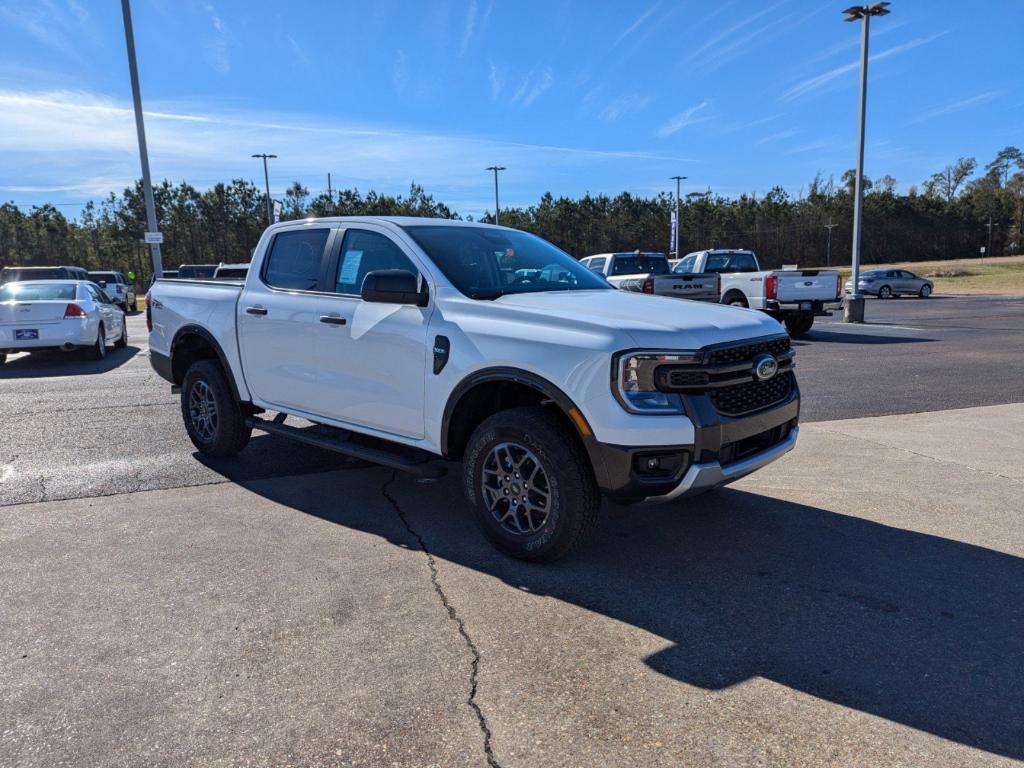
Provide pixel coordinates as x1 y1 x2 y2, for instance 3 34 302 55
463 407 600 562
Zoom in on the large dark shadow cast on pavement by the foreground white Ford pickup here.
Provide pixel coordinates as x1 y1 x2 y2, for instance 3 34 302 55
228 469 1024 759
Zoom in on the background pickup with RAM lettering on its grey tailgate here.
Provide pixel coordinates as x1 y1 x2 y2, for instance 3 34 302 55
580 251 721 301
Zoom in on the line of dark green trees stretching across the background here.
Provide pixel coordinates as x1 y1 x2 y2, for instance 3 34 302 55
0 146 1024 281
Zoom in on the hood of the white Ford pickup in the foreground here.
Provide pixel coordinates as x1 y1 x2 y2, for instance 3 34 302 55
494 291 784 349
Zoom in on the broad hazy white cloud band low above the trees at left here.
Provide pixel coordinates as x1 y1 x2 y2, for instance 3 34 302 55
0 88 688 204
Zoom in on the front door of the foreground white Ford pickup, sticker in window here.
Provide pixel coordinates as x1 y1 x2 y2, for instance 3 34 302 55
311 224 431 438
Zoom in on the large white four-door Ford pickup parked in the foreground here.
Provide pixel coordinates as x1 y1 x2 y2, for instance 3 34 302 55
146 217 800 561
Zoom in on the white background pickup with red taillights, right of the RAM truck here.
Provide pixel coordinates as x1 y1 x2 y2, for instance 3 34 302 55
675 248 843 337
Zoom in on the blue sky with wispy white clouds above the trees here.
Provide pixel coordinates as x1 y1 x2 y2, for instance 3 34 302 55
0 0 1024 217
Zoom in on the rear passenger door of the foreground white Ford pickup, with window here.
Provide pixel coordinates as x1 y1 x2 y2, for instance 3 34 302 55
237 224 334 412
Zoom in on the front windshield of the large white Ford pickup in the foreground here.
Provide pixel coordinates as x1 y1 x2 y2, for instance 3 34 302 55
404 225 611 299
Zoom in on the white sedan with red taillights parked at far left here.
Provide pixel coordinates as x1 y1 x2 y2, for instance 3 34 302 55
0 280 128 365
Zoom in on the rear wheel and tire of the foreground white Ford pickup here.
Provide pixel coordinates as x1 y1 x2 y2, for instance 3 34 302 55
181 360 253 457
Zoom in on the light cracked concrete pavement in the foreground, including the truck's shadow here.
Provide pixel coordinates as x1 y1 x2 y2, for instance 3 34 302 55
0 404 1024 768
